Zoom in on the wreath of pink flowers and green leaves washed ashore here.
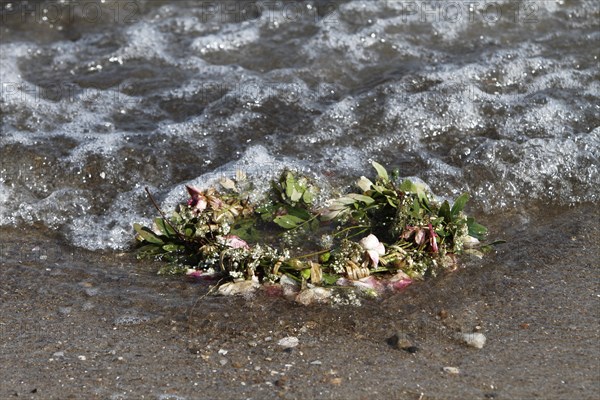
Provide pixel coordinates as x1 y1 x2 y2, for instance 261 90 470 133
134 162 495 304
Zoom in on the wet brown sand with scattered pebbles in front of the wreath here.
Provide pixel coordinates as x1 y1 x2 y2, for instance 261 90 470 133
0 205 600 400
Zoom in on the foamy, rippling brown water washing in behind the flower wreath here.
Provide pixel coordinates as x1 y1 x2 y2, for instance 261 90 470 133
0 1 600 249
